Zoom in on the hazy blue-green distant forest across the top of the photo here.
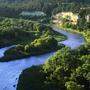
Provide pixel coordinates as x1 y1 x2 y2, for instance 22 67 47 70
0 0 90 17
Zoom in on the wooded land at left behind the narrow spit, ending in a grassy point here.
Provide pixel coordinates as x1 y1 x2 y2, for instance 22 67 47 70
0 18 66 47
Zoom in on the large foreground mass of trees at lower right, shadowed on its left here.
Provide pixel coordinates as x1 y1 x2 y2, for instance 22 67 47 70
17 44 90 90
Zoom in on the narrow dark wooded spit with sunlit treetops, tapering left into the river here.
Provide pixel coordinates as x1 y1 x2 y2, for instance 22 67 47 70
0 36 64 62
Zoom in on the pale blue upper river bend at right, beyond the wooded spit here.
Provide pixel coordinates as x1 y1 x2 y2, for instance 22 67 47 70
53 27 85 49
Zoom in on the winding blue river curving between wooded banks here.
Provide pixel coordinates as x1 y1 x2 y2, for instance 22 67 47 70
0 28 84 90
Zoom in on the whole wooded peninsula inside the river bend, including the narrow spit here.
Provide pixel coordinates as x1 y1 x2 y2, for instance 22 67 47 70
0 18 66 61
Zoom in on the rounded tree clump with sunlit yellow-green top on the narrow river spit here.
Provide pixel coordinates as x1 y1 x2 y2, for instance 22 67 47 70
25 36 58 54
